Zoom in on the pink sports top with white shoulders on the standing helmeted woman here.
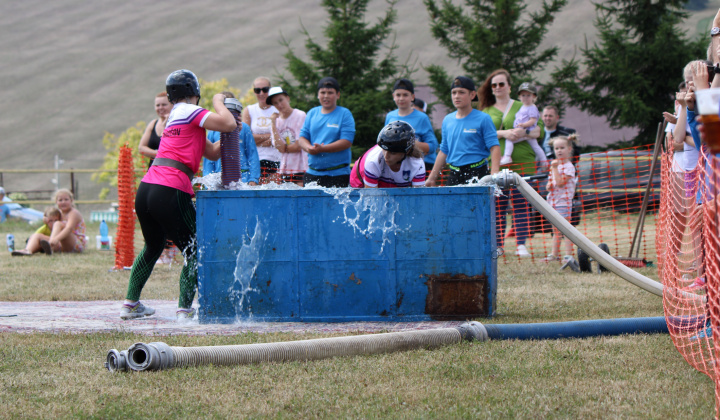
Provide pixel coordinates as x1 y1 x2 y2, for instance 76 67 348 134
142 102 210 196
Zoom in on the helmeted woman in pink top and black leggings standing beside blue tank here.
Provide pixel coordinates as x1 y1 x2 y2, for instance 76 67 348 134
120 70 237 321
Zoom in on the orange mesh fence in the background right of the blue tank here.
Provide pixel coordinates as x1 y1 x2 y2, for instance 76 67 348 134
496 146 661 266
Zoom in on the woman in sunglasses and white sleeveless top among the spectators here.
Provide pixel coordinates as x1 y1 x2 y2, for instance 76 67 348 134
242 77 281 183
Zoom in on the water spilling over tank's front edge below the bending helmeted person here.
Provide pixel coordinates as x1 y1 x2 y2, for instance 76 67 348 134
324 188 407 254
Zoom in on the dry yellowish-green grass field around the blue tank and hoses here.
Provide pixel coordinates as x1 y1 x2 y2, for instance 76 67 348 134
0 218 715 419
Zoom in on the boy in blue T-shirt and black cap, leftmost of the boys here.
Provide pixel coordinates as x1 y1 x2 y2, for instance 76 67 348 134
298 77 355 188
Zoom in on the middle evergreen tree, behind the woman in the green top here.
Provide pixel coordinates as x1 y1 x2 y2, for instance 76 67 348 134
424 0 567 109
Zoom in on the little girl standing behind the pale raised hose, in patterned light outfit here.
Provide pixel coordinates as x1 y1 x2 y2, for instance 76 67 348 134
543 134 577 271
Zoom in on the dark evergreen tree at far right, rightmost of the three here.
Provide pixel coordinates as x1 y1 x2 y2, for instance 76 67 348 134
553 0 709 145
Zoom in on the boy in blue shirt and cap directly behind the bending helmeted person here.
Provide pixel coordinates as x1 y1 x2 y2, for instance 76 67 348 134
385 79 438 171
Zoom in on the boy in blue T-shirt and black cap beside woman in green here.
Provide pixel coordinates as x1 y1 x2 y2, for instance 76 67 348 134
425 76 501 187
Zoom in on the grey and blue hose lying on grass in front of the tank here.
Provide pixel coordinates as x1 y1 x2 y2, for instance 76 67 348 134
105 317 668 372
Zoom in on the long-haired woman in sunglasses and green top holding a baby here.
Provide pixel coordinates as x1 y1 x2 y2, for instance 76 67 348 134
478 69 544 257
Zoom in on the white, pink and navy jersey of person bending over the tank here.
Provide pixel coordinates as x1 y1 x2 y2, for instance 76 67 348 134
350 145 425 188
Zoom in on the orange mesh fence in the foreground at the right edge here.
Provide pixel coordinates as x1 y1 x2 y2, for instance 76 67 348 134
657 144 720 417
